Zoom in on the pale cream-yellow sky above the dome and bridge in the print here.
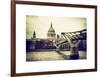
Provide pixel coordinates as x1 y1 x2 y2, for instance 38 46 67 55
26 15 87 39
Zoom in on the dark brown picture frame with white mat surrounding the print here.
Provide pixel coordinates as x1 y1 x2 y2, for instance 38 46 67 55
11 0 97 77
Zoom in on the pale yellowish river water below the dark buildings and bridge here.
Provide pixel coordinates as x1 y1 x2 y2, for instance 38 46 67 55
26 51 87 61
